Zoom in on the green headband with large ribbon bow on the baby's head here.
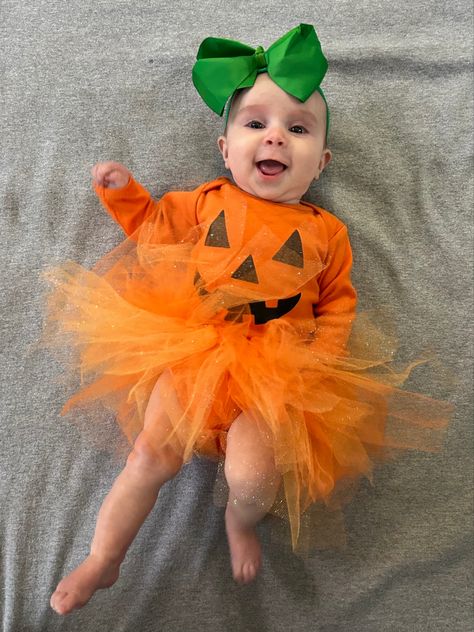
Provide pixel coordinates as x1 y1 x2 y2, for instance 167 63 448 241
193 24 329 138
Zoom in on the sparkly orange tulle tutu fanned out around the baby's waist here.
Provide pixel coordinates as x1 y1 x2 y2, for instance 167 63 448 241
43 216 451 546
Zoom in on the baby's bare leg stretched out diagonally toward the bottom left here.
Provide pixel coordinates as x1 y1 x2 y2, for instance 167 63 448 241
51 375 182 614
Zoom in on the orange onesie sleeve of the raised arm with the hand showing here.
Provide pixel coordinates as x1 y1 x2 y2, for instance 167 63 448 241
94 178 198 238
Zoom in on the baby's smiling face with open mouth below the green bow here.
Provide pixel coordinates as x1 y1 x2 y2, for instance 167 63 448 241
218 73 331 204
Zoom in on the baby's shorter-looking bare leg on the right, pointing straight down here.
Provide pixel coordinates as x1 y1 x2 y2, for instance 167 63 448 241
225 413 280 583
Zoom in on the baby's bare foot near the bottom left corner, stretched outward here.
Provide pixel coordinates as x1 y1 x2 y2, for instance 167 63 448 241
50 555 119 614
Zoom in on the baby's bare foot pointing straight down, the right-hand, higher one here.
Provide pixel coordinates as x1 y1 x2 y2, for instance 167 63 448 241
225 507 261 584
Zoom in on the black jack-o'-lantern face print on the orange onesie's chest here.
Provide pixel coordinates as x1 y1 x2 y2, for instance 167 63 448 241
195 209 322 325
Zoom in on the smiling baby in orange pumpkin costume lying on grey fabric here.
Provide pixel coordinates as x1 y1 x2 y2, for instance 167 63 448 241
51 25 452 614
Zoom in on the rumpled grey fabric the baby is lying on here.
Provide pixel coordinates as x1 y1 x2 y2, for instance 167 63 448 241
0 0 473 632
